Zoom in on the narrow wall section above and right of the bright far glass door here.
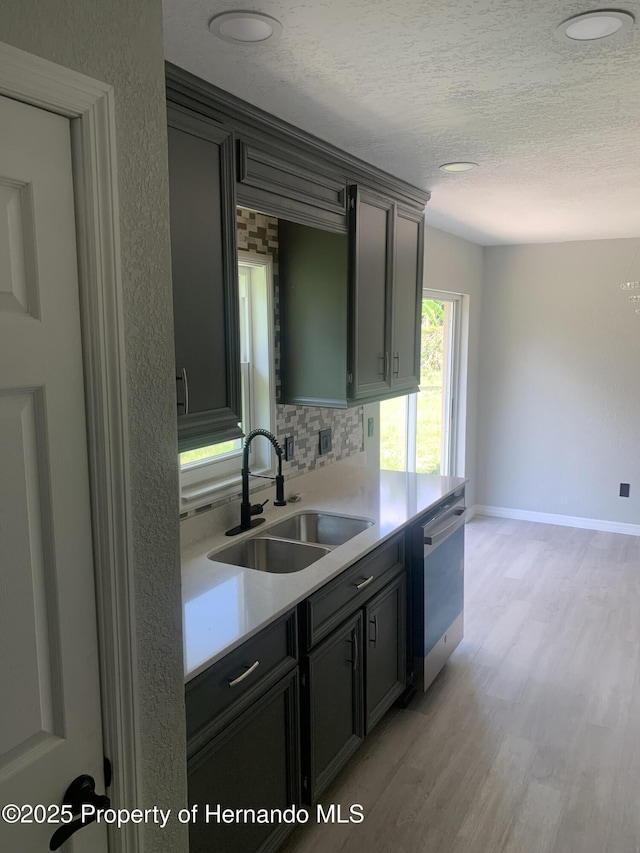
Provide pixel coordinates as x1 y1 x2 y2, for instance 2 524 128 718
424 226 483 506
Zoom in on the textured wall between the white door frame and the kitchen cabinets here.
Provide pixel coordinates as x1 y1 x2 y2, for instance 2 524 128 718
0 0 188 853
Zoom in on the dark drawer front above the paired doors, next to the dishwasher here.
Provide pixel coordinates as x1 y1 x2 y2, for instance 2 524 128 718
303 536 404 648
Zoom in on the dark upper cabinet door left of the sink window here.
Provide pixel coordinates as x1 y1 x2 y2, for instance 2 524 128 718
168 107 242 450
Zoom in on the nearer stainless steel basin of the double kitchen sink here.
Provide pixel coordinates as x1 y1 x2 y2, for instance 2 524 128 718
209 531 330 574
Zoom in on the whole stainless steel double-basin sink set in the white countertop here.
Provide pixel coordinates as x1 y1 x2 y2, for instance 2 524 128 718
209 512 373 574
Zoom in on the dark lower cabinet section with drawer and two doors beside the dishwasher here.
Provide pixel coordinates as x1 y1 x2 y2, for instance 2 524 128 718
298 536 407 804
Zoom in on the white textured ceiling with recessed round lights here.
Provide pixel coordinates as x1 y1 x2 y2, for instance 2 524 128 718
164 0 640 245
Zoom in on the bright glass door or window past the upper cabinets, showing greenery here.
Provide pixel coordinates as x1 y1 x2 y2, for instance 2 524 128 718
380 291 461 475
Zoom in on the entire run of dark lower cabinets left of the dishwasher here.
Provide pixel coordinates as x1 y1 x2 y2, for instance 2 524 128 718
186 548 407 853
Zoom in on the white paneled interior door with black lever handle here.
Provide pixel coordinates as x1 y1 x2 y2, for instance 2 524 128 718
0 98 107 853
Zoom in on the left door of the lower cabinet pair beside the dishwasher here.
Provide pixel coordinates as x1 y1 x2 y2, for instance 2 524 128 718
302 611 364 803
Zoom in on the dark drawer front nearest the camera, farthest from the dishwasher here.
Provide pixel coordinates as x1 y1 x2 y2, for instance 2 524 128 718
186 612 298 755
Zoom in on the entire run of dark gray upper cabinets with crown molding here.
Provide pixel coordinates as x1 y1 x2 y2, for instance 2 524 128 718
167 65 429 412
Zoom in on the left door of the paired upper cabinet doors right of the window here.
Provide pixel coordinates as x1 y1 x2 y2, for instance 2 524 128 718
349 186 393 400
